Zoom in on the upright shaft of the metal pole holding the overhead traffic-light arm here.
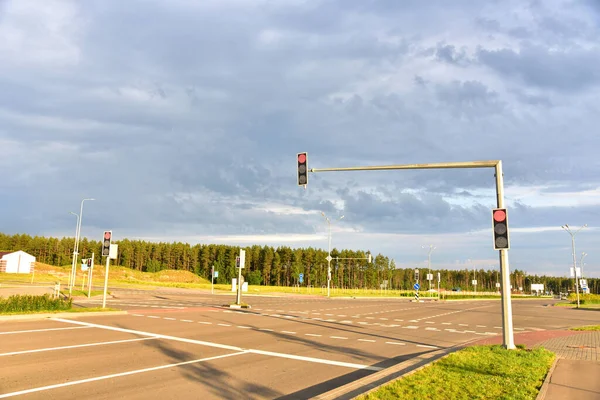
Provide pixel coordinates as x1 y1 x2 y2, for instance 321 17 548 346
495 161 516 349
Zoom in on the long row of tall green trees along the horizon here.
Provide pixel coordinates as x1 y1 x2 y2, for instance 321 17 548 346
0 233 600 293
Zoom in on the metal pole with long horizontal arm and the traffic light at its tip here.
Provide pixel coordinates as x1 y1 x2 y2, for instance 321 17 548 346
308 159 515 349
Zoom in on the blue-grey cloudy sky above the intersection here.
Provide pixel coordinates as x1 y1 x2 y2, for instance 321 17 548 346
0 0 600 277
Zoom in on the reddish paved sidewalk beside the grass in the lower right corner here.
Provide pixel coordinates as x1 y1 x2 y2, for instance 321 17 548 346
474 330 600 400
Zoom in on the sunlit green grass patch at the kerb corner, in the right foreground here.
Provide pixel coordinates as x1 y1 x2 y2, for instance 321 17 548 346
358 345 555 400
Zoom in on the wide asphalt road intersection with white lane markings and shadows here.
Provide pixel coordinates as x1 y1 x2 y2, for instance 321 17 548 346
0 289 597 399
